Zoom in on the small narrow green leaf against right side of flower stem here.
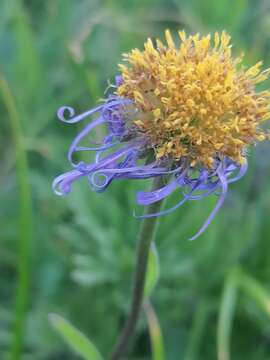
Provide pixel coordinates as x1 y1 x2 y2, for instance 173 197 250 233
144 243 159 299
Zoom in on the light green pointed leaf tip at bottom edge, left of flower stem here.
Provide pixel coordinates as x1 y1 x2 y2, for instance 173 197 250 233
49 314 102 360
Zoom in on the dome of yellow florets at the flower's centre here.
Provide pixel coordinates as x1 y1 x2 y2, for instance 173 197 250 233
117 30 270 167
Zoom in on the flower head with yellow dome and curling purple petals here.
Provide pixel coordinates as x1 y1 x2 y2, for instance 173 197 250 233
53 30 270 239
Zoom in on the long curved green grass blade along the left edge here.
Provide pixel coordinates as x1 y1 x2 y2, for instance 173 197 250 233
0 76 32 360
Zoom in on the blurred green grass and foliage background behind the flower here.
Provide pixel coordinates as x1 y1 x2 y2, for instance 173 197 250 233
0 0 270 360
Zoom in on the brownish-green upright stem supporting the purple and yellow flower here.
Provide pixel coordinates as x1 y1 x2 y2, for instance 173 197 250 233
110 177 165 360
